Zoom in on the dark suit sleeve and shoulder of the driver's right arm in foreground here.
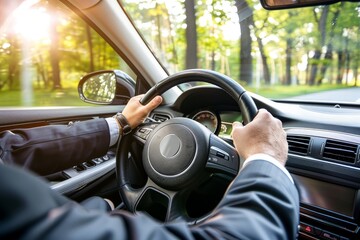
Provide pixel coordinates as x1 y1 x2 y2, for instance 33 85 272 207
0 160 299 240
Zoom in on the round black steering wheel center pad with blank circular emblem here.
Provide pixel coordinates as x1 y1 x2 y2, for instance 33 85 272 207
143 118 210 189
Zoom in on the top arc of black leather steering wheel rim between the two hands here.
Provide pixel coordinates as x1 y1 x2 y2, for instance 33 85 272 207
140 69 257 124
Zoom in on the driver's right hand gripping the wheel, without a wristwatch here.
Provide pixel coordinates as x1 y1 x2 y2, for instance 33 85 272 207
232 109 288 165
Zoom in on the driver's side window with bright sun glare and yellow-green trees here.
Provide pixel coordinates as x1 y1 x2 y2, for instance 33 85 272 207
0 0 136 107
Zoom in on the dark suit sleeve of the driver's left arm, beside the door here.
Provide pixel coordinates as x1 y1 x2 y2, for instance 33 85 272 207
0 119 110 175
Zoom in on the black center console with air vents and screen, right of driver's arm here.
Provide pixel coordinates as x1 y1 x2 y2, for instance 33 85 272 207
286 129 360 240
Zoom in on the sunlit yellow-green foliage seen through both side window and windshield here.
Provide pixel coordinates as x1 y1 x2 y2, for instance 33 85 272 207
0 0 360 106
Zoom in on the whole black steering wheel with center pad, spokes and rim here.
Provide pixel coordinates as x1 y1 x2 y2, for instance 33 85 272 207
116 69 257 223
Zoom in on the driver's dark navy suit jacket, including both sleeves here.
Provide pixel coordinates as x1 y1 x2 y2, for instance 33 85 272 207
0 120 299 240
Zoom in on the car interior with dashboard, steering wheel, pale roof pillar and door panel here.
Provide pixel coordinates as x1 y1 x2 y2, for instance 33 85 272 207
0 0 360 240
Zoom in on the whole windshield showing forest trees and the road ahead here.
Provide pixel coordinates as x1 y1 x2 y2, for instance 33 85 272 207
122 0 360 103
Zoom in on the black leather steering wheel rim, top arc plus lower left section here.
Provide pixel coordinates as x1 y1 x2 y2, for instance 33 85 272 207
116 69 257 212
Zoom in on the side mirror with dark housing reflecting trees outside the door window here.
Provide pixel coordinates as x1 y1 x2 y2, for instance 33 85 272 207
78 70 135 105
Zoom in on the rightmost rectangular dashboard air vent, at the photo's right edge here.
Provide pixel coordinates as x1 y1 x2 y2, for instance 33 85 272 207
323 140 358 163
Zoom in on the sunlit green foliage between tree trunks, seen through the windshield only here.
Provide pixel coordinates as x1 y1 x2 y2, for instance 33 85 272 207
123 0 360 85
